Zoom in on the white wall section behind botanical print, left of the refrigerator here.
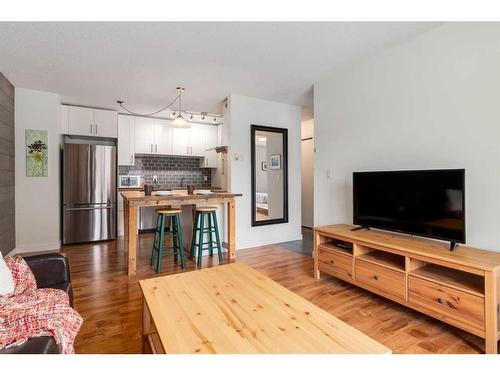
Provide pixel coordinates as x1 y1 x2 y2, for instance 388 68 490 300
15 88 60 252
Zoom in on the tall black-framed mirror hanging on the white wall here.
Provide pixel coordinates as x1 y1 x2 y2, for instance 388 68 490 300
250 125 288 227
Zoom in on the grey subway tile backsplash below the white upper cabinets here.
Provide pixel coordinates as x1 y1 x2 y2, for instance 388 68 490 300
119 155 211 188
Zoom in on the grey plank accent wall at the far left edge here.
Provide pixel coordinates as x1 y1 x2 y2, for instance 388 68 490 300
0 73 16 255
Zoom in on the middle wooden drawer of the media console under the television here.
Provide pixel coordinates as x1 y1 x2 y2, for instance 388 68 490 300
355 259 405 299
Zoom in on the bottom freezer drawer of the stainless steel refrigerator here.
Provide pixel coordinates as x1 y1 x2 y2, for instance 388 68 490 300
63 204 116 244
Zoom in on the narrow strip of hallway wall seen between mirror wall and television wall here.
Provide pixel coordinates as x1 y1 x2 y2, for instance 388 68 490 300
301 119 314 228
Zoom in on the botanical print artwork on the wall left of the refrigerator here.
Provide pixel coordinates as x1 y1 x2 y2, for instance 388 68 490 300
25 129 49 177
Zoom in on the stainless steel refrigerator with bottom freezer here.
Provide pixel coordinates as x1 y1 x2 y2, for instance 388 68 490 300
62 138 117 244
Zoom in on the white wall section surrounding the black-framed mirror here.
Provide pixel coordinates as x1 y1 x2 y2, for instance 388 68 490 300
224 95 302 249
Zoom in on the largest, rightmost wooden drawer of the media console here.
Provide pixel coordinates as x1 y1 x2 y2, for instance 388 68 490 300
408 276 484 329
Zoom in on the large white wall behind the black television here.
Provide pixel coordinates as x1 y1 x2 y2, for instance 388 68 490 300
314 23 500 250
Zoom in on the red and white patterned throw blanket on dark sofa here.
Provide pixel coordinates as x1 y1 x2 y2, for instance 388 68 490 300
0 256 83 354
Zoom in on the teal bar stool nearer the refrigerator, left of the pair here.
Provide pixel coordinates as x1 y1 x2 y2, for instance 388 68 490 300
149 208 186 273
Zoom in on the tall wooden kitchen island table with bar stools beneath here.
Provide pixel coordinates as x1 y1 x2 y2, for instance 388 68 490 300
120 191 241 276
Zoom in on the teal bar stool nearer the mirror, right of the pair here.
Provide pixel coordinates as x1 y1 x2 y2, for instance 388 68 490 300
189 207 223 267
